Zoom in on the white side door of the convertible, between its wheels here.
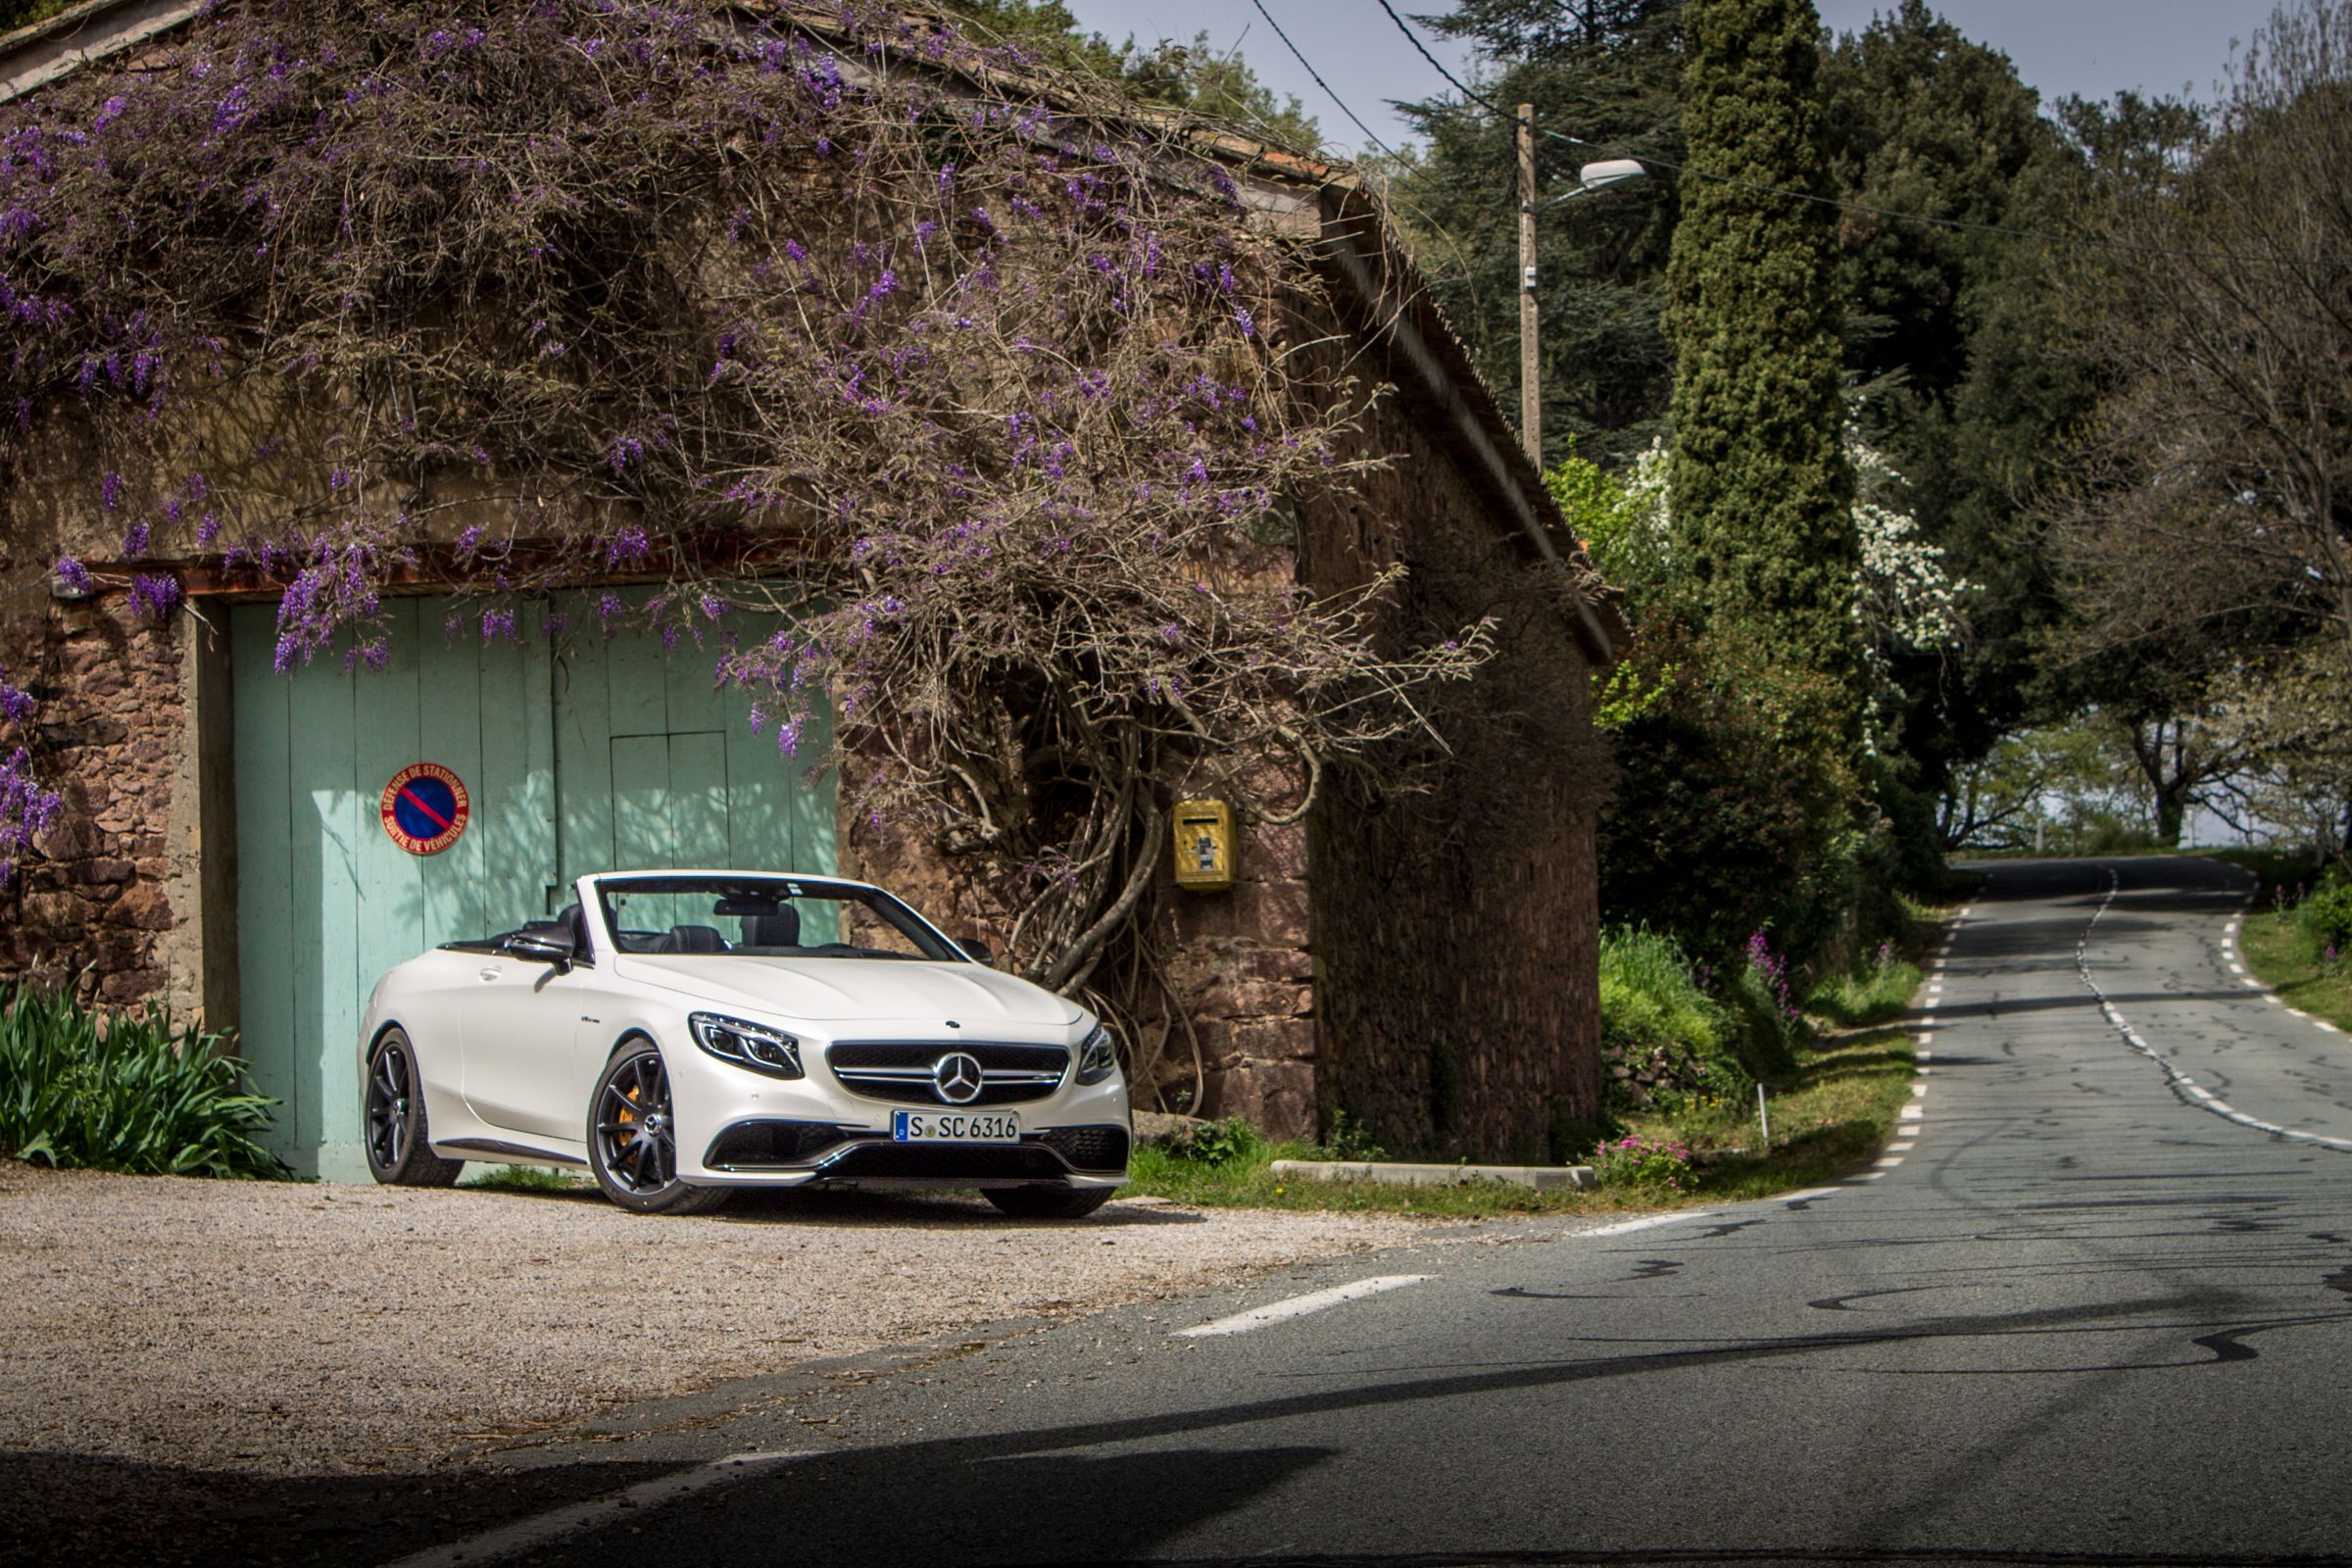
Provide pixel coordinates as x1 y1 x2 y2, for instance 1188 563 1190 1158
461 953 593 1143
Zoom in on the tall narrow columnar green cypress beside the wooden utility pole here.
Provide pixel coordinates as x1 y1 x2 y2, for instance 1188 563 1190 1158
1668 0 1865 728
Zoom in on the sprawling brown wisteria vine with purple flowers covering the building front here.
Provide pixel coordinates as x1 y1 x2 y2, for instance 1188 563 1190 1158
0 0 1492 1067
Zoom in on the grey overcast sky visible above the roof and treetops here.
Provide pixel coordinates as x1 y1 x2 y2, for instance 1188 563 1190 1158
1065 0 2275 153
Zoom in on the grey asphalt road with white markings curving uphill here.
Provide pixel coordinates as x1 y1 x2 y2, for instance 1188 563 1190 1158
36 860 2352 1568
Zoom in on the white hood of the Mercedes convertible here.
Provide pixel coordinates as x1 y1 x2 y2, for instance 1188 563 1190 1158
613 953 1084 1030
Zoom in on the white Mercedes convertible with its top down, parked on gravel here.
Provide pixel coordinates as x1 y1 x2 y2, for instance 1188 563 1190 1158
360 870 1131 1218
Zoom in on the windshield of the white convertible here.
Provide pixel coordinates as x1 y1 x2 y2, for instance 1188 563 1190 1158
595 877 966 964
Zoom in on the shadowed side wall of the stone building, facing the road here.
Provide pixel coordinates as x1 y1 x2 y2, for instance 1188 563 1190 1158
1303 380 1609 1161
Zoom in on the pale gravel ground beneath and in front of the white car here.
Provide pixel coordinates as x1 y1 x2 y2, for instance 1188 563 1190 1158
0 1161 1433 1476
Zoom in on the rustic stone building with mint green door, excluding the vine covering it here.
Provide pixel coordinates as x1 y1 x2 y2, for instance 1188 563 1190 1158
0 0 1616 1180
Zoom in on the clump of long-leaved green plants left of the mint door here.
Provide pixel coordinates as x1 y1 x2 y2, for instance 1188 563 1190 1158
0 985 287 1178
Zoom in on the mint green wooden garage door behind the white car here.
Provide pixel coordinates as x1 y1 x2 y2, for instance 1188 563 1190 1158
230 600 835 1180
